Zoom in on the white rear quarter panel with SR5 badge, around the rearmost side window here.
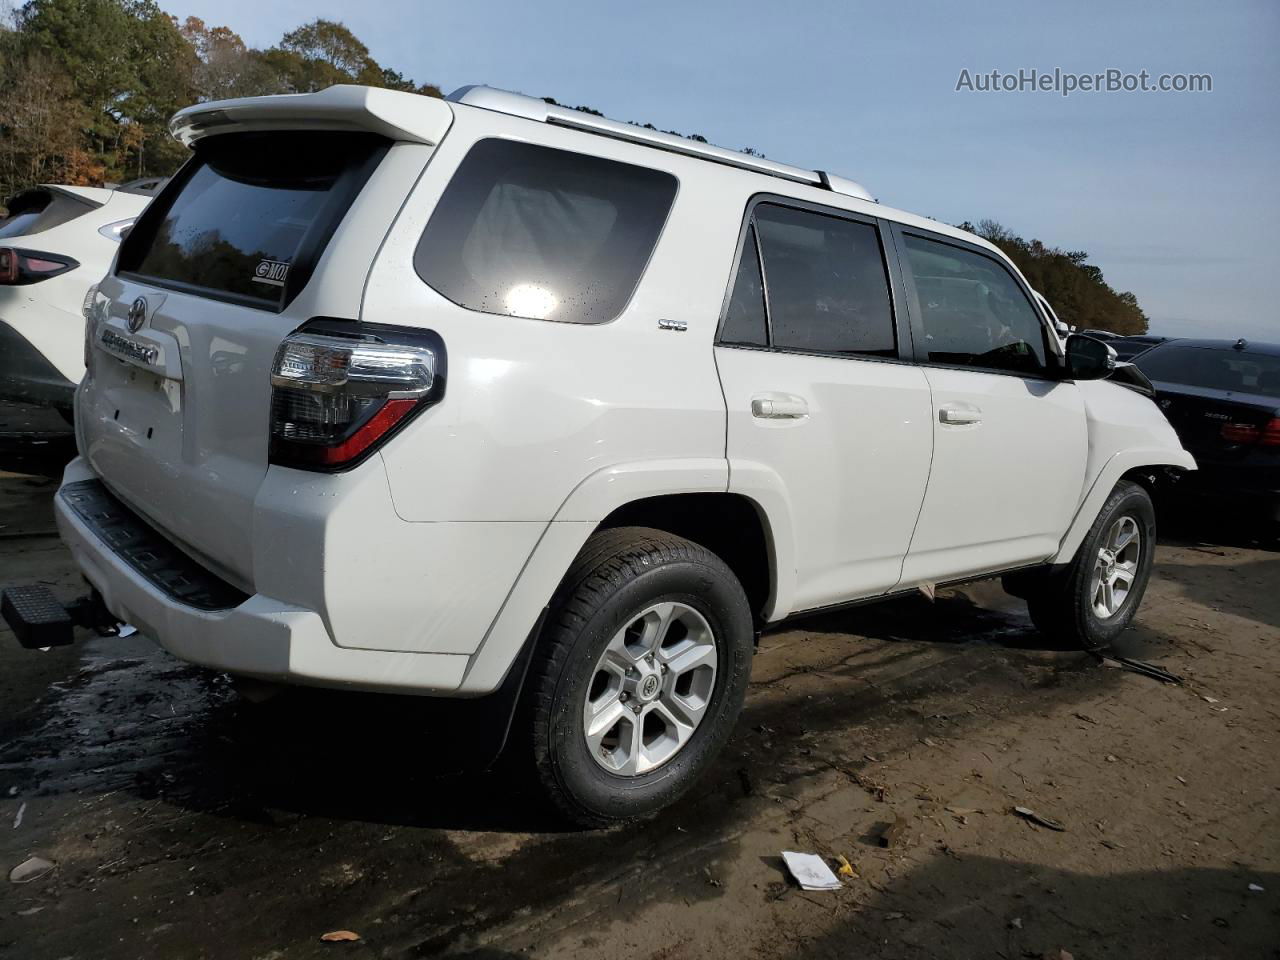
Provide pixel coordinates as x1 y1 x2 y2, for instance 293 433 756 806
361 109 746 524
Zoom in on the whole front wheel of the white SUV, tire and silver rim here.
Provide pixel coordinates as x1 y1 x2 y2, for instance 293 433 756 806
1027 480 1156 650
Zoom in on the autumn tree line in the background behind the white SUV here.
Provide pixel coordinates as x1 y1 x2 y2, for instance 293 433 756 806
0 0 1147 333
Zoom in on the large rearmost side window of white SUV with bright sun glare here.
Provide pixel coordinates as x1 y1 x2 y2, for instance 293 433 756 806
413 140 676 324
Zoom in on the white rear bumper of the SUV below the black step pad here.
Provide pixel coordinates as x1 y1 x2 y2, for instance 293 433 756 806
54 460 470 694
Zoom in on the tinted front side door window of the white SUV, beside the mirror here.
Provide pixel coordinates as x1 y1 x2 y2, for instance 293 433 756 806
904 234 1044 372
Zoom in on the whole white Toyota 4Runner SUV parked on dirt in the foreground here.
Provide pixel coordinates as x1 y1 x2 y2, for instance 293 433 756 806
49 87 1194 823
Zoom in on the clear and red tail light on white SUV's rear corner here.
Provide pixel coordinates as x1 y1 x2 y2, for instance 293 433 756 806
270 321 444 471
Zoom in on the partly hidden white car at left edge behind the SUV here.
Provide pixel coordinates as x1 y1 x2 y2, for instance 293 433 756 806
0 180 159 417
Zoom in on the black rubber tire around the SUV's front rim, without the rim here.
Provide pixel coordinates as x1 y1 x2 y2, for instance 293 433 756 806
1027 480 1156 650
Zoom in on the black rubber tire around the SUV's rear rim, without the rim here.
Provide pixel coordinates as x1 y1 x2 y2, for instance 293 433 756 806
522 527 754 827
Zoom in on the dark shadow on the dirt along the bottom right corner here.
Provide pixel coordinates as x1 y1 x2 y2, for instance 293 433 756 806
768 855 1280 960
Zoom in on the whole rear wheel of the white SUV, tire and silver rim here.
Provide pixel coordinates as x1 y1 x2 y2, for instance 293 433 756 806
525 527 753 826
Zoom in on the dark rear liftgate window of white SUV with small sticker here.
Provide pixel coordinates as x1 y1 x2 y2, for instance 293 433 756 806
119 132 388 310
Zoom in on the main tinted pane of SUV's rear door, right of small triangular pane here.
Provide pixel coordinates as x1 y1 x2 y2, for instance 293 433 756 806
755 204 896 356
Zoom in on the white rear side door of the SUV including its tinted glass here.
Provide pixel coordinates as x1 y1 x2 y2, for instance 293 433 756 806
716 198 933 614
